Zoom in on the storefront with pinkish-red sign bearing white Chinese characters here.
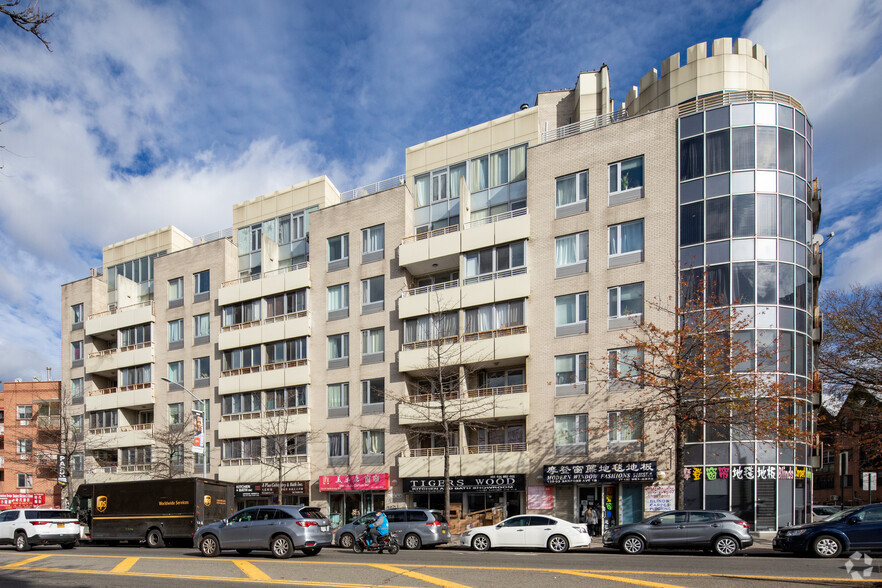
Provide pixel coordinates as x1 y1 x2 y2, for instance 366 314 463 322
319 474 389 528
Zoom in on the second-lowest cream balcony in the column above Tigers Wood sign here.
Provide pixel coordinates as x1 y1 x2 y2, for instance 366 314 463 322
398 385 530 425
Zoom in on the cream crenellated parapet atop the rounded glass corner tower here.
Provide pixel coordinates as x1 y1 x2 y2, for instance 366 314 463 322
625 37 769 116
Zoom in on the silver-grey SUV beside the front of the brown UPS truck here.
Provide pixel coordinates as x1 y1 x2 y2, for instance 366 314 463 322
193 506 331 559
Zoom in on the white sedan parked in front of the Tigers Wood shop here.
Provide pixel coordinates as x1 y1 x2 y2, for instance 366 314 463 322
459 515 591 553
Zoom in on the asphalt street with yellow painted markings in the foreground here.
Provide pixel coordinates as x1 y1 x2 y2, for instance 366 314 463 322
0 545 882 588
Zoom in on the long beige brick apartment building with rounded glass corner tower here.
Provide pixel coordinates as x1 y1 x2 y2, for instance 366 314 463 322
62 39 822 530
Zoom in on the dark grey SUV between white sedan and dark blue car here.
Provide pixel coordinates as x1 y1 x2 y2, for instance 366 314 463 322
603 510 753 555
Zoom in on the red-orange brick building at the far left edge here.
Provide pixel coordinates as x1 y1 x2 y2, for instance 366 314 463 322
0 381 62 510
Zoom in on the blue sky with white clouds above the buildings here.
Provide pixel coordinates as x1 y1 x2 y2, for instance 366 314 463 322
0 0 882 382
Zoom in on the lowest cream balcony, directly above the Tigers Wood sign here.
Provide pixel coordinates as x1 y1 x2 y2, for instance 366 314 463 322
398 443 530 478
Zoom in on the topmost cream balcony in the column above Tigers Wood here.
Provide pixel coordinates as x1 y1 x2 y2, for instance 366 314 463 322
398 208 530 276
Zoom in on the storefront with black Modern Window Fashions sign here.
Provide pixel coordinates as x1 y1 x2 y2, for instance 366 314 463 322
542 461 657 534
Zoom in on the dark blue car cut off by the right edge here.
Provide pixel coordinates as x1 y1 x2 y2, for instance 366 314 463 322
772 504 882 557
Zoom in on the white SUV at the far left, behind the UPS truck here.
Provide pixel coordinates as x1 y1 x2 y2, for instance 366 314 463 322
0 508 80 551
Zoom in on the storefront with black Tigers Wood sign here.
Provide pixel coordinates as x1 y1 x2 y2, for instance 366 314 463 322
401 474 526 518
